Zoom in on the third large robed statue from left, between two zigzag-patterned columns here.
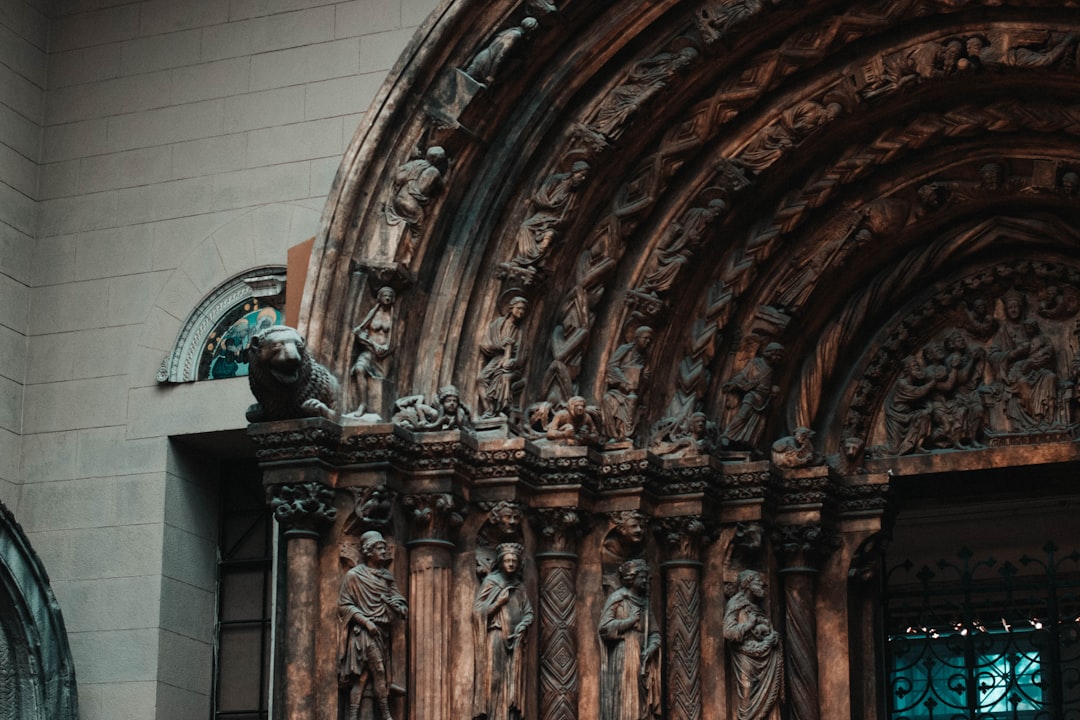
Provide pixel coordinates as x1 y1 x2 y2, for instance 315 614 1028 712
599 559 661 720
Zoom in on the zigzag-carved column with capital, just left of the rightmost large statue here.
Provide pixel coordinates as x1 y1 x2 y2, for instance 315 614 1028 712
659 515 705 720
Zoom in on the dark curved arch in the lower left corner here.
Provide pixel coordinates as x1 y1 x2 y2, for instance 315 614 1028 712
0 504 79 720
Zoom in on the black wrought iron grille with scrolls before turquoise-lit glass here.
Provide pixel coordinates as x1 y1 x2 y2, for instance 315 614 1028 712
882 542 1080 720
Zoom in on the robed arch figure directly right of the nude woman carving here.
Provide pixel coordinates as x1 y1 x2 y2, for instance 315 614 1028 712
476 297 528 418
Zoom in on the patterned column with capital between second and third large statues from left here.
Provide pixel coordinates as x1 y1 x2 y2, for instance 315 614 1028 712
534 507 583 720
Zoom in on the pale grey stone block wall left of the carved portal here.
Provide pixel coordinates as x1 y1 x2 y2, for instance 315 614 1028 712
0 0 435 720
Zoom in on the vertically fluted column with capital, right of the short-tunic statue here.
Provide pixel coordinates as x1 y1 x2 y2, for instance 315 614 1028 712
404 492 462 720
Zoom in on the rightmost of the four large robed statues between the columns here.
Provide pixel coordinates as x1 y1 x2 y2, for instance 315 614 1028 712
724 570 784 720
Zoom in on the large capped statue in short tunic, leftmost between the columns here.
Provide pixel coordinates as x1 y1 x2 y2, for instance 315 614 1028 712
338 530 408 720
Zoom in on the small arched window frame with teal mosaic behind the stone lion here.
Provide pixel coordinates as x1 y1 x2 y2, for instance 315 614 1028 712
158 266 285 383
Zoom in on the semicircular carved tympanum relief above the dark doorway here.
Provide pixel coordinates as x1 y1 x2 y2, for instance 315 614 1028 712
869 282 1080 456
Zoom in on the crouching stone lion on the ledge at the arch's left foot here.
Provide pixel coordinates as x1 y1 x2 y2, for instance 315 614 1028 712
247 325 338 422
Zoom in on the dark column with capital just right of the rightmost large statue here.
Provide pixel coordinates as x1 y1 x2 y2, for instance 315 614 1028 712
775 525 833 720
